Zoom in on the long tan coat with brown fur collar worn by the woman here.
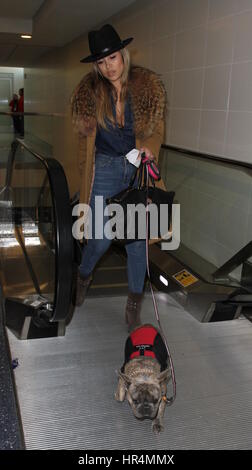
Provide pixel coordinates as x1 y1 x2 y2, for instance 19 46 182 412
71 66 166 241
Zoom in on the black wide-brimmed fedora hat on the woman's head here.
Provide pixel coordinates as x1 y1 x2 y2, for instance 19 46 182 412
81 24 133 62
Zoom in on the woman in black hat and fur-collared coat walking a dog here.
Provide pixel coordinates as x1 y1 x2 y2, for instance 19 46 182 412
71 24 166 331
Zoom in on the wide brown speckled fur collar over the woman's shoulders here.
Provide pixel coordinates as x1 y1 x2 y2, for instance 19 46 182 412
71 67 166 139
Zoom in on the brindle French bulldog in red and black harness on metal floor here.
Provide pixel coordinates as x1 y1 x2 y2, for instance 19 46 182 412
115 324 171 434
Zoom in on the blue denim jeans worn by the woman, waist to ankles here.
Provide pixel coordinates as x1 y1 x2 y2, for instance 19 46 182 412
79 154 146 294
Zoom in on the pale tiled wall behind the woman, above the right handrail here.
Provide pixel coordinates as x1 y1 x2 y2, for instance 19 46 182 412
25 0 252 162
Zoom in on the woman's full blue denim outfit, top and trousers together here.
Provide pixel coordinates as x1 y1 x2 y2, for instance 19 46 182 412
79 99 146 293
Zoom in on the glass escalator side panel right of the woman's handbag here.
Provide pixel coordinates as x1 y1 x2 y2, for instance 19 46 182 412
160 148 252 286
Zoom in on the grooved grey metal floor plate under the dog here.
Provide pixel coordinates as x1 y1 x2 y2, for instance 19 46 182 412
5 294 252 450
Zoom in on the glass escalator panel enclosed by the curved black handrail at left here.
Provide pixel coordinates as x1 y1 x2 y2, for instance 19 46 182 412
0 139 55 302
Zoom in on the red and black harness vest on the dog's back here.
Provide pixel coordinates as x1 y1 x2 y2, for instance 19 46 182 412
121 325 168 372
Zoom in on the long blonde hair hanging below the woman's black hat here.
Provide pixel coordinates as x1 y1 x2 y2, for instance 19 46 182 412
93 48 130 129
